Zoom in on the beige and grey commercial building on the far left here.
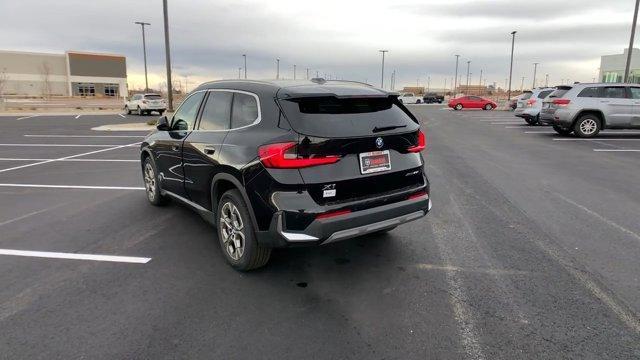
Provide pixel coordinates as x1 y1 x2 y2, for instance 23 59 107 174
0 50 128 97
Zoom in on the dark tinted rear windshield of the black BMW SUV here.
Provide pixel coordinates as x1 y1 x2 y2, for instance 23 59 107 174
280 96 419 137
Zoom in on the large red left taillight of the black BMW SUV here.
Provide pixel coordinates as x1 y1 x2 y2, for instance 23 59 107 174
258 142 340 169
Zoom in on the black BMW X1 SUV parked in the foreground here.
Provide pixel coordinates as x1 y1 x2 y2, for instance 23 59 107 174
140 79 431 270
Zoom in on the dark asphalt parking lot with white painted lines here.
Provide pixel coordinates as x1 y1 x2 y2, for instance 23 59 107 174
0 111 640 359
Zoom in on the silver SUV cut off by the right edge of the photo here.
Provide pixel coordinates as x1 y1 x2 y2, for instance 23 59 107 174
540 83 640 138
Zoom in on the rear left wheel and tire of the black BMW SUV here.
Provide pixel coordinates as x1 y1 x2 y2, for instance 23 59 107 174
216 189 271 271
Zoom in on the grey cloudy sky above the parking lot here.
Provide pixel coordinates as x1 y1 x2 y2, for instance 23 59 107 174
0 0 640 88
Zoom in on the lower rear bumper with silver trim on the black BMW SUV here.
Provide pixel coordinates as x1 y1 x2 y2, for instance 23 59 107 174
258 194 431 247
